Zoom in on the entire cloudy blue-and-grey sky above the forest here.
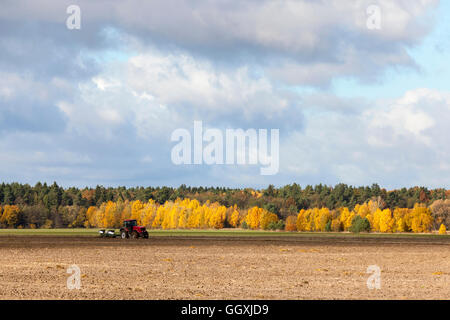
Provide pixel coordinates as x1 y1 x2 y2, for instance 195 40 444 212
0 0 450 189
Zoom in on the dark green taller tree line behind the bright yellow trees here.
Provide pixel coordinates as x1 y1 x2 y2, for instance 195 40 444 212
0 182 450 228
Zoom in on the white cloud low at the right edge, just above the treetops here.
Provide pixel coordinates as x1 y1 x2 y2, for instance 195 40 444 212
280 89 450 188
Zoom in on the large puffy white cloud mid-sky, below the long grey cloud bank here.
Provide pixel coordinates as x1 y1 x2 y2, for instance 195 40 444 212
52 48 301 139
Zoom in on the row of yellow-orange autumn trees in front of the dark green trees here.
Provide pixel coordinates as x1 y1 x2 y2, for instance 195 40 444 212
0 198 450 234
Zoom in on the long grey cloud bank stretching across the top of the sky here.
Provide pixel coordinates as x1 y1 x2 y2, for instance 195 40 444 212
0 0 439 90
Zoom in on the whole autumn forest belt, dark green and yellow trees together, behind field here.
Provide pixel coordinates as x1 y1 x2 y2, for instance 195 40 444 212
0 182 450 232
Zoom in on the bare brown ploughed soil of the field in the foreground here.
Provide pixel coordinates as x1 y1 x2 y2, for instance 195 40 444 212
0 236 450 299
